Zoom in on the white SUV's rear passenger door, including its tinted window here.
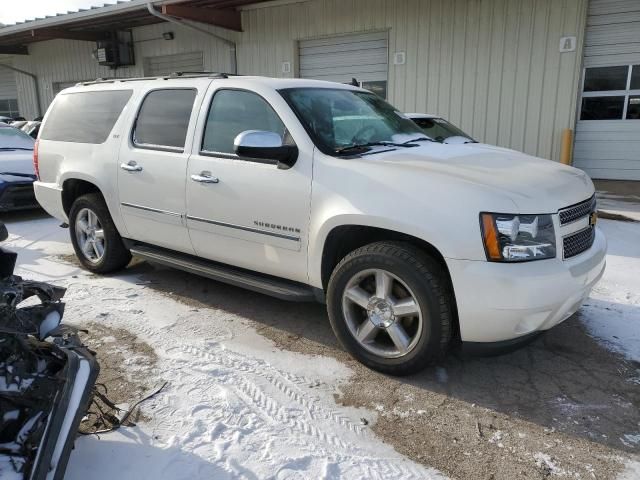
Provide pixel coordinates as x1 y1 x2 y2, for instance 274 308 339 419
118 79 205 253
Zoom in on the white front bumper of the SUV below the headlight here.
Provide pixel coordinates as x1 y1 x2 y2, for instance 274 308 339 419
446 228 607 343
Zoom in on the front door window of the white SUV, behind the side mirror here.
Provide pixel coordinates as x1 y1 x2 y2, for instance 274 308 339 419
202 90 286 154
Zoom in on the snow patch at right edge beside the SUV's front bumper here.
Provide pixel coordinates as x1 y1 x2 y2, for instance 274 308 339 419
580 220 640 362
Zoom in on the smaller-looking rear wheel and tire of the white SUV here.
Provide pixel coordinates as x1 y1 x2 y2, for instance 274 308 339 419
69 193 131 273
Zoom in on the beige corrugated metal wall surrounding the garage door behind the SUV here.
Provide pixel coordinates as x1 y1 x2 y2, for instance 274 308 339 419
238 0 587 160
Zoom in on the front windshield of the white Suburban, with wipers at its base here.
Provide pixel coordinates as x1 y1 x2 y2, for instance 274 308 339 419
280 88 424 155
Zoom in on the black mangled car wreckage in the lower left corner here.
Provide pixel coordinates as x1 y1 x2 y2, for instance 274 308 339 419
0 222 99 480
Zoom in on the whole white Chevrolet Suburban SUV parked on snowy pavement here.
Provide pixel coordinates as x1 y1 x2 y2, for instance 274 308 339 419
34 74 606 374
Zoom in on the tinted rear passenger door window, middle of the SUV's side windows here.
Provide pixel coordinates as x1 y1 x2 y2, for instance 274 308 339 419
133 88 196 151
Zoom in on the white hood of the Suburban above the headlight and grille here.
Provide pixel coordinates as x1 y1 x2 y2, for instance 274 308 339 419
364 143 595 213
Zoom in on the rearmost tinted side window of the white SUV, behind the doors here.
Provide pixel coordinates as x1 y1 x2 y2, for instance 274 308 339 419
40 90 132 143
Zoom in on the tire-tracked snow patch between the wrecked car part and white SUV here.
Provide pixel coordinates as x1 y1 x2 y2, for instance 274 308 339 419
6 215 443 480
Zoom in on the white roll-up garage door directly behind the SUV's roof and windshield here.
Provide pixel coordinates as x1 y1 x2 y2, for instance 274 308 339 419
300 32 389 97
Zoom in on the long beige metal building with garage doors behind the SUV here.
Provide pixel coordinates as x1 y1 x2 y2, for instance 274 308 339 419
0 0 640 179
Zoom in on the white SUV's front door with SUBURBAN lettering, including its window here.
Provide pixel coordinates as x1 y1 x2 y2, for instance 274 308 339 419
187 88 313 282
